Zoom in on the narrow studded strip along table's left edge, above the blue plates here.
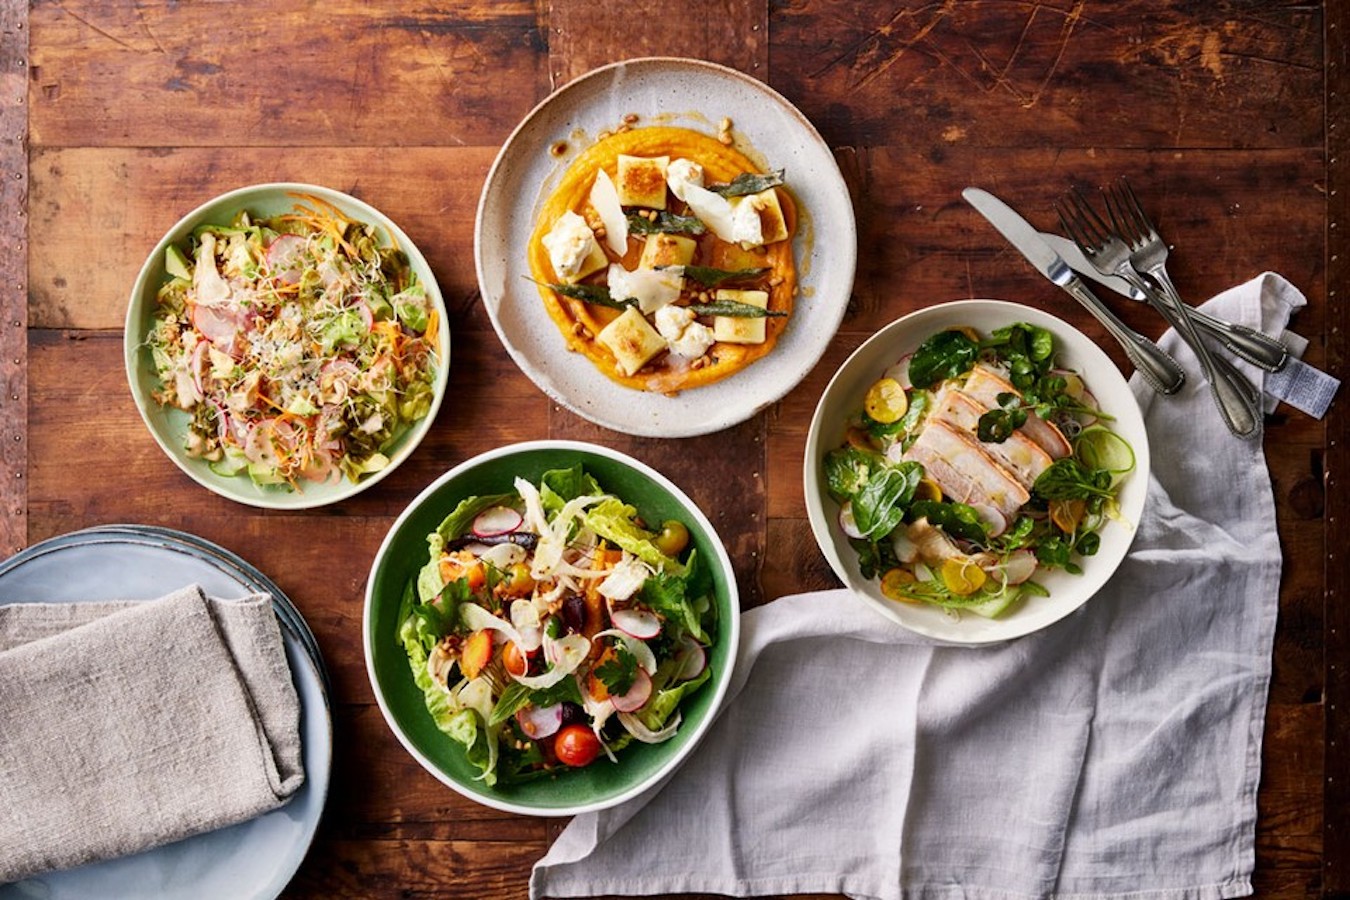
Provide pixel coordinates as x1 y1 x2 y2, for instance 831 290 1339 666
0 1 30 556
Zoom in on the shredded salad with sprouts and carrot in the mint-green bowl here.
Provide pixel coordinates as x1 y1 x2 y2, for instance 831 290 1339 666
146 197 441 490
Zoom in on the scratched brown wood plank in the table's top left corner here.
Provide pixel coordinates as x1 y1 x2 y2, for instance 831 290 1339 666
31 0 547 147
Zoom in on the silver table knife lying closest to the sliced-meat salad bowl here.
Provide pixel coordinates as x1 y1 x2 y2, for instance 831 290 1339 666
961 188 1185 394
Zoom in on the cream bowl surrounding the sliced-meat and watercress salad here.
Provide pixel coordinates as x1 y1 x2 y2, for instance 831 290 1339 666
803 300 1149 644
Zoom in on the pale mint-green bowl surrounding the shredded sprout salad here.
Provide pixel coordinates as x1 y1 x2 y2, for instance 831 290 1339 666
123 184 450 509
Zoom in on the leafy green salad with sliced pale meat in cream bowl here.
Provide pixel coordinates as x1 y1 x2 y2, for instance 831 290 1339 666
824 322 1134 617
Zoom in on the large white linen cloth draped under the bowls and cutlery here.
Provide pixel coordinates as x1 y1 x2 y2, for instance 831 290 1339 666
531 273 1305 900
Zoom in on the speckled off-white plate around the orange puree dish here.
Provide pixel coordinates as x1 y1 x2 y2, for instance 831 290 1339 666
474 58 857 437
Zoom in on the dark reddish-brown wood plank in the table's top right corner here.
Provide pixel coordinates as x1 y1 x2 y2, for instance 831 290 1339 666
771 0 1322 158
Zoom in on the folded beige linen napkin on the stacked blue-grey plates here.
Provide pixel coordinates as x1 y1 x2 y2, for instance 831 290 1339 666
0 586 304 882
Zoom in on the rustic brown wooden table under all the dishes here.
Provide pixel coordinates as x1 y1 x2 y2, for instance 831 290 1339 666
0 0 1350 897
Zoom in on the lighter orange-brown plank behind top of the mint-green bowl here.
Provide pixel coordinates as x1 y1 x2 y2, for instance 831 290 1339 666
30 147 497 330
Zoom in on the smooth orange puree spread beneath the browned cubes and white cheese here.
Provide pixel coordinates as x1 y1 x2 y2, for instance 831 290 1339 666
529 125 797 393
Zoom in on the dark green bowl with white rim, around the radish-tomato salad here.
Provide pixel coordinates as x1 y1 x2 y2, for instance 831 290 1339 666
362 441 740 816
